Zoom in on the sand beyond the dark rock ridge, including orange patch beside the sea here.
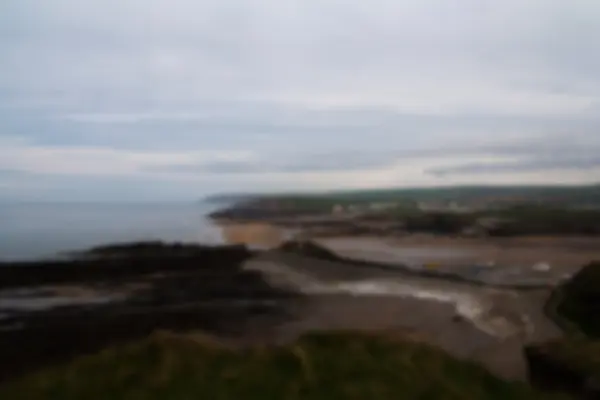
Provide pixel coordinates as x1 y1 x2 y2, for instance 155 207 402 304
216 223 600 275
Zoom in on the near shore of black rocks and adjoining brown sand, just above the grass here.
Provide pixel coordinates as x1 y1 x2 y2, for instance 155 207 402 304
0 239 560 380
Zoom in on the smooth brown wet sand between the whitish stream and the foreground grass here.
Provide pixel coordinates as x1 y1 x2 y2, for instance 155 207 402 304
276 295 527 381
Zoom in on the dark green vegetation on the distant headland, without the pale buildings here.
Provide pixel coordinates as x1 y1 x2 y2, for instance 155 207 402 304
213 186 600 236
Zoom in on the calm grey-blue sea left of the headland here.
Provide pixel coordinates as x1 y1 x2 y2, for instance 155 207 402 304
0 202 223 260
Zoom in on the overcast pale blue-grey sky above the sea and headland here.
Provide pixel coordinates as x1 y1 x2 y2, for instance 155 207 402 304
0 0 600 201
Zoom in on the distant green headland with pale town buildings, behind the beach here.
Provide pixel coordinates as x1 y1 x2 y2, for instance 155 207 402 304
211 186 600 236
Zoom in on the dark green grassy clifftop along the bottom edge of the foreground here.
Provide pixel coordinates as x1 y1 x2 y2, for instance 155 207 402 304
0 333 564 400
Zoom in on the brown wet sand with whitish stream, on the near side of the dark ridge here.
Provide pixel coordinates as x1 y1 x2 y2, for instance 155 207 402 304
245 251 561 380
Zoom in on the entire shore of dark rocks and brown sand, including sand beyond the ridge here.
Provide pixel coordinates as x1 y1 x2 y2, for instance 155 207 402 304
0 198 595 392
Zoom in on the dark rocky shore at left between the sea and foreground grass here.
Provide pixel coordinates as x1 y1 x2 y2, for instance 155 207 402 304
0 243 297 381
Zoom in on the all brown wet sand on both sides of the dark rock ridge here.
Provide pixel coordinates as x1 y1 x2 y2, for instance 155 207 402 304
206 224 600 380
